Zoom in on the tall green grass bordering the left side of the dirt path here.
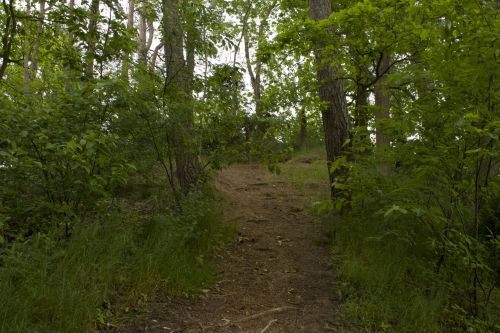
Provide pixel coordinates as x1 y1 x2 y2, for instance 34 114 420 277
0 189 228 333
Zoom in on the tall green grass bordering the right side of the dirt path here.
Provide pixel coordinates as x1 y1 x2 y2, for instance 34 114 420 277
333 214 448 333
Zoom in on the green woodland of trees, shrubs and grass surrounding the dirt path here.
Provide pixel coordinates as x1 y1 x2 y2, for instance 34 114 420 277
0 0 500 332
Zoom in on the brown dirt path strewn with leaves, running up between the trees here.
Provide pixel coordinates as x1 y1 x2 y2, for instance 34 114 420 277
132 165 338 333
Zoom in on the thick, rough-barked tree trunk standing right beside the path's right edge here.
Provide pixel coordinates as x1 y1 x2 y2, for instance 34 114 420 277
309 0 351 198
